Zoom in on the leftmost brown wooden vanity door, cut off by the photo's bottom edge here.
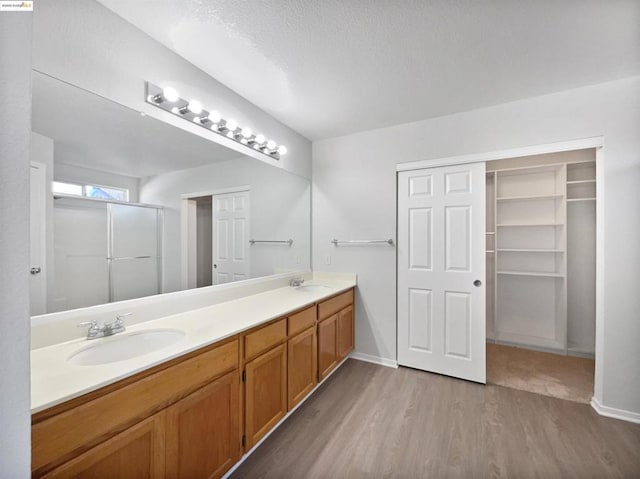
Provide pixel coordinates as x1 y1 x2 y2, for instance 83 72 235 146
44 412 165 479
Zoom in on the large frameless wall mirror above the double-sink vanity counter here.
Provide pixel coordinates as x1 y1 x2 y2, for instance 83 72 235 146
31 71 311 315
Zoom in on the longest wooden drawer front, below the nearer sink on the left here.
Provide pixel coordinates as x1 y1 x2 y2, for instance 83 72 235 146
31 339 238 477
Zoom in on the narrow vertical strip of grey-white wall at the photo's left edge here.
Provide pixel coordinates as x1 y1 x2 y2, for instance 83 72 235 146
0 12 32 479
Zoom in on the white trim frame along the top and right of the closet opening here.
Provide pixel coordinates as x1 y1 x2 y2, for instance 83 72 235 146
396 136 605 406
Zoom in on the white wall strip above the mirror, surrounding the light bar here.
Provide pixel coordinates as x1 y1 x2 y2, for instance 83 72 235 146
33 0 311 178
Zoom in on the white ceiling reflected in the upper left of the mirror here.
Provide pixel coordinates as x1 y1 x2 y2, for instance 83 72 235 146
33 72 242 177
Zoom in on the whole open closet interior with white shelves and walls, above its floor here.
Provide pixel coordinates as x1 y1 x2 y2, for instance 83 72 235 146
486 149 596 402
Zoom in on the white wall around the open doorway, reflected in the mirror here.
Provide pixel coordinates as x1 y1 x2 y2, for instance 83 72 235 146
140 157 311 292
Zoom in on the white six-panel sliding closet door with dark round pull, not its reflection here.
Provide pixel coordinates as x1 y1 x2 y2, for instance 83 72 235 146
398 163 486 383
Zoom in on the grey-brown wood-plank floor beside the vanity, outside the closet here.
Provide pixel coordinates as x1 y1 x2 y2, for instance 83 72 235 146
231 359 640 479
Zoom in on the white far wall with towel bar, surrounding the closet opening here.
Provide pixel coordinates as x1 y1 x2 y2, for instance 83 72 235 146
312 77 640 413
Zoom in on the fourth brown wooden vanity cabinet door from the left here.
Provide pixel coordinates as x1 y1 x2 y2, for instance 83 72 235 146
287 327 318 409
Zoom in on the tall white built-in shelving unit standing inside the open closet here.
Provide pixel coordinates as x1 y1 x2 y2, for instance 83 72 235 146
487 165 567 351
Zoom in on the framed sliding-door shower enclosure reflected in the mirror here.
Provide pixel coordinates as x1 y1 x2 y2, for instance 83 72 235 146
51 195 162 311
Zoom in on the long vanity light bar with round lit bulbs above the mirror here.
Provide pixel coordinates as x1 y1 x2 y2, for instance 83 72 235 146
145 82 287 159
